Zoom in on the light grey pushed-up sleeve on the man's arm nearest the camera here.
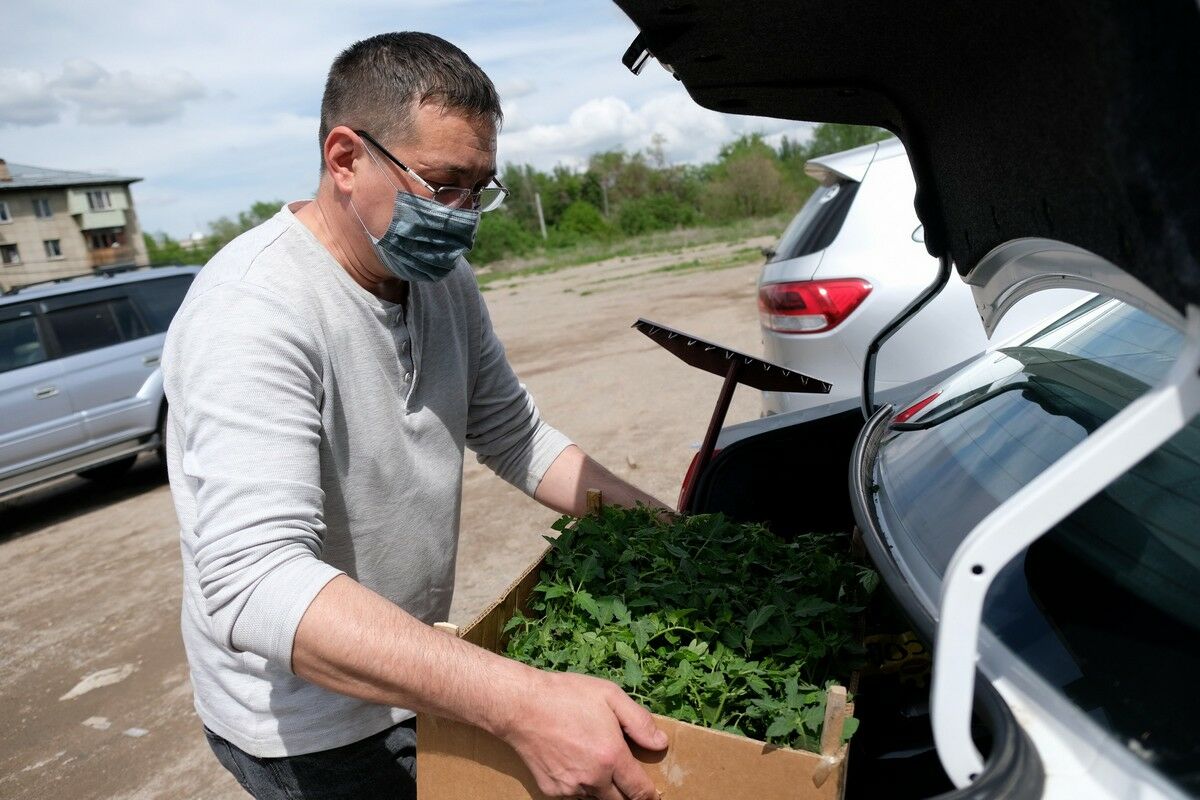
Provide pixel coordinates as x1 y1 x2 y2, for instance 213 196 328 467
163 283 341 669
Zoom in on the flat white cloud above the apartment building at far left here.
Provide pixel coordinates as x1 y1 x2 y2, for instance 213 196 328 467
0 59 205 126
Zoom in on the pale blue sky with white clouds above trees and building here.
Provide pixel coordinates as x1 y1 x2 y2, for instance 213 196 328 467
0 0 809 239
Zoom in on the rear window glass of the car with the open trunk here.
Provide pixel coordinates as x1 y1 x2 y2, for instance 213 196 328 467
877 301 1200 790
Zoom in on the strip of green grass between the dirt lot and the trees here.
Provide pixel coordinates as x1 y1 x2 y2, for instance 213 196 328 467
478 215 790 289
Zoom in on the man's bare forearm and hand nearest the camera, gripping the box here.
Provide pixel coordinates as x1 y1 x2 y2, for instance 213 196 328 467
292 575 667 800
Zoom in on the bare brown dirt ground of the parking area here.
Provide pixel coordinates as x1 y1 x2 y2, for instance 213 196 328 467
0 240 762 800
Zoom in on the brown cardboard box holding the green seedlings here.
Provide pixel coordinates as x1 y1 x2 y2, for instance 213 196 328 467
416 544 853 800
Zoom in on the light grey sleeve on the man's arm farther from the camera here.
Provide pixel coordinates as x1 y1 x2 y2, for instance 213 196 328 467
467 299 571 497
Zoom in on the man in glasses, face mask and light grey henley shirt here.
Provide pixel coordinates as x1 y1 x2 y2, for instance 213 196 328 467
164 34 666 800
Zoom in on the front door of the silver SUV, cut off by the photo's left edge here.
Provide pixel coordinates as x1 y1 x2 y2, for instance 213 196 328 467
0 303 86 477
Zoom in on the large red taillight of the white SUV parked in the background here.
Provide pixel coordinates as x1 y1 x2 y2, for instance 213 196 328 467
758 278 871 333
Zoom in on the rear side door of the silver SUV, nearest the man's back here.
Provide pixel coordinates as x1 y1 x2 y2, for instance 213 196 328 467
43 285 163 447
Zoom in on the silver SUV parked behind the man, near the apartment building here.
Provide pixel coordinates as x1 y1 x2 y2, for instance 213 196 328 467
0 267 199 498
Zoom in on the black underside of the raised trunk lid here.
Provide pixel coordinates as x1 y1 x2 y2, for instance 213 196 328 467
614 0 1200 311
